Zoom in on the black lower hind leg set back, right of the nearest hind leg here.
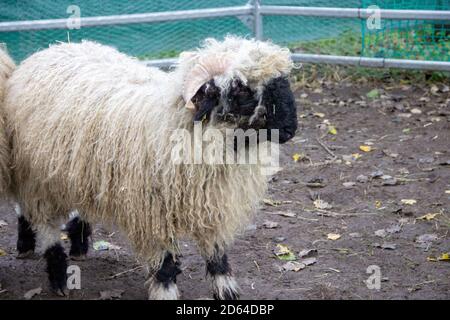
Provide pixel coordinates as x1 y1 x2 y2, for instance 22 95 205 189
66 217 92 260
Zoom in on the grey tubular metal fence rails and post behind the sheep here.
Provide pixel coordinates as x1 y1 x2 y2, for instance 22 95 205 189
0 0 450 71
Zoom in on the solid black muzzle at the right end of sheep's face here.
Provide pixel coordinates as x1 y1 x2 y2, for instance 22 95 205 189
262 77 298 143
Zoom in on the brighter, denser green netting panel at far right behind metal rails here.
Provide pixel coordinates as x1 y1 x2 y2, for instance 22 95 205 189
361 0 450 61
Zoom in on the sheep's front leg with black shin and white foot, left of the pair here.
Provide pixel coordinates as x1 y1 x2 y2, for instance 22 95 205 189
149 252 181 300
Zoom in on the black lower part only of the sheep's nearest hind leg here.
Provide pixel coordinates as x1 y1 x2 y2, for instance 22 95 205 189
44 243 67 296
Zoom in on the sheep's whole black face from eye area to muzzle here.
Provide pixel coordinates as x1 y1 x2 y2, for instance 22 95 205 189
192 77 297 143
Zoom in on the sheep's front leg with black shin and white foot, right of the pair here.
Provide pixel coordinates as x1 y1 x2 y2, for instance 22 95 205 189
205 250 239 300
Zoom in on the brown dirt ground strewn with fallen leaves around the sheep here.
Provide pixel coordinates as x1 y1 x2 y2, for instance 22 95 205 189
0 75 450 299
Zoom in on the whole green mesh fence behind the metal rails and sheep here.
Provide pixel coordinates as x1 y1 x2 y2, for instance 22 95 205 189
0 0 450 61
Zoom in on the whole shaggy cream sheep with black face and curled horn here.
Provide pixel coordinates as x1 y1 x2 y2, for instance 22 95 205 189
0 36 297 299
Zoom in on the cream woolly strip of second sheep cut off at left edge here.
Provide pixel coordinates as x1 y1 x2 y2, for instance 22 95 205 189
0 47 16 198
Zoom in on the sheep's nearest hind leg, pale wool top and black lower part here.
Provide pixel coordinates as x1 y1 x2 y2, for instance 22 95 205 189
37 224 68 296
